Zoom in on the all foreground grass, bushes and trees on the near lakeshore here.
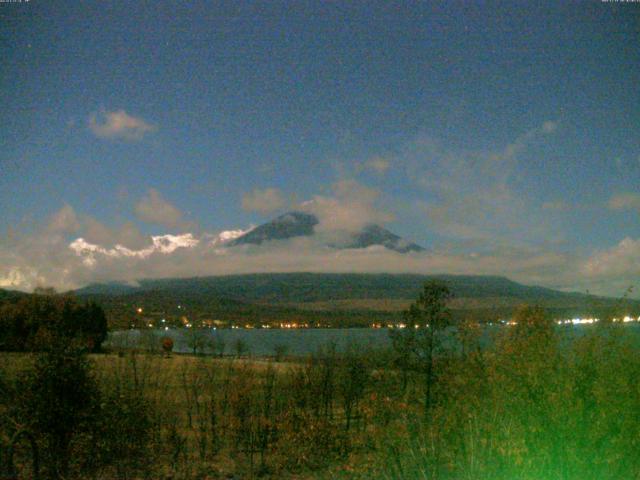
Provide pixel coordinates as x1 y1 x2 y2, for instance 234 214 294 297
0 284 640 480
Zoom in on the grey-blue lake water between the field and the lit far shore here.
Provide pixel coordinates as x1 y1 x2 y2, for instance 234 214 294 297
105 323 640 356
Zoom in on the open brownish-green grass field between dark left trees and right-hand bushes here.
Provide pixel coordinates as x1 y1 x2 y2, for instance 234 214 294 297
0 353 404 478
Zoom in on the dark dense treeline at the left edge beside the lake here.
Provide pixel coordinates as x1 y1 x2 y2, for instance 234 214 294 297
0 289 107 352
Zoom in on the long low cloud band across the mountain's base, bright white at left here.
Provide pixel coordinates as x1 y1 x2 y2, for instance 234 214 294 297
0 196 640 295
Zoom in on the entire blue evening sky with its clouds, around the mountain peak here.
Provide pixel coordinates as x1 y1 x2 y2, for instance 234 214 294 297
0 0 640 296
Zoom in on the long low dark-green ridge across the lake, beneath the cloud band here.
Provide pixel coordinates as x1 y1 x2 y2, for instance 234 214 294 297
66 272 640 328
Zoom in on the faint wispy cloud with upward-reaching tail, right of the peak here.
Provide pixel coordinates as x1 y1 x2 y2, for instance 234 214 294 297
408 121 558 246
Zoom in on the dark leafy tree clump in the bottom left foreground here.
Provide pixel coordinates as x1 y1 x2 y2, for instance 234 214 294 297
11 336 151 480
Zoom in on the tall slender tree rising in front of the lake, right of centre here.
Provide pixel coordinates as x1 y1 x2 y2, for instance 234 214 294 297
390 281 452 420
